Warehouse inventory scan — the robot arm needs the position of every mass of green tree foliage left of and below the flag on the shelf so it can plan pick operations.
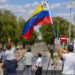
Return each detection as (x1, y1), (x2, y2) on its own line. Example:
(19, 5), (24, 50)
(0, 10), (38, 43)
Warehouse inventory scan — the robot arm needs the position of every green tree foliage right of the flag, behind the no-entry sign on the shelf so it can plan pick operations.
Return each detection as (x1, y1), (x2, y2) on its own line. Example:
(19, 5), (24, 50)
(40, 17), (74, 44)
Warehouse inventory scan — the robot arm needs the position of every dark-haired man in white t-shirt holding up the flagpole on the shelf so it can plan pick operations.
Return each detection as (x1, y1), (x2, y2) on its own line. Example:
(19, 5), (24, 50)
(57, 45), (75, 75)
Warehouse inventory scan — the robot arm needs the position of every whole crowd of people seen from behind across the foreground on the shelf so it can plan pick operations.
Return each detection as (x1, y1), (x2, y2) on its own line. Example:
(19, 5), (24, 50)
(0, 43), (75, 75)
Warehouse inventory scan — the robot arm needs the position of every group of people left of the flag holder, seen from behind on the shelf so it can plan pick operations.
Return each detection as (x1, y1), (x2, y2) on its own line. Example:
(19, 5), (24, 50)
(0, 43), (42, 75)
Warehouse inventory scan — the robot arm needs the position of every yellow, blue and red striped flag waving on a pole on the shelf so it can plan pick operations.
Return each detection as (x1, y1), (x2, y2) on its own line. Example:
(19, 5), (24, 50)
(22, 4), (51, 40)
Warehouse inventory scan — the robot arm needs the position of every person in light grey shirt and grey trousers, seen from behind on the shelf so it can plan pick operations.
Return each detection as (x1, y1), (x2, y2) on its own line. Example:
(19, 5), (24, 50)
(23, 48), (34, 75)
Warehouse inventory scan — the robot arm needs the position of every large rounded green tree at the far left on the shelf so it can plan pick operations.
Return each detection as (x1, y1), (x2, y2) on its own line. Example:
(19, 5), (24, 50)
(0, 10), (20, 44)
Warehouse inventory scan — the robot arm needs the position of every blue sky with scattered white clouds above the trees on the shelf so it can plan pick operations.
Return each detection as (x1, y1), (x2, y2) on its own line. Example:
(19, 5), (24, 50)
(0, 0), (75, 39)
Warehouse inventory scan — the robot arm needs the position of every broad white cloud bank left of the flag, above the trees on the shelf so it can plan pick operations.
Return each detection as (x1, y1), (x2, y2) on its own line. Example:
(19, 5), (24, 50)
(0, 2), (39, 19)
